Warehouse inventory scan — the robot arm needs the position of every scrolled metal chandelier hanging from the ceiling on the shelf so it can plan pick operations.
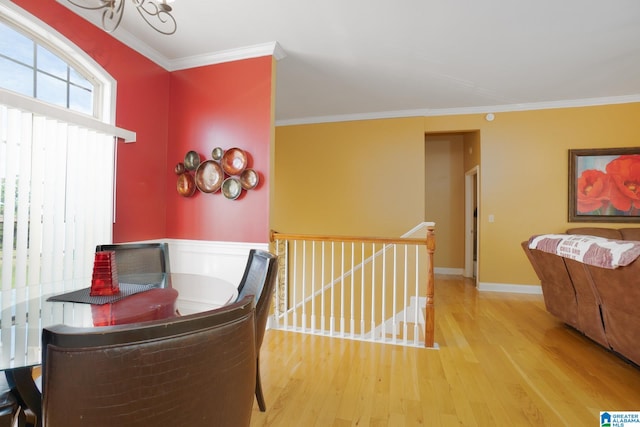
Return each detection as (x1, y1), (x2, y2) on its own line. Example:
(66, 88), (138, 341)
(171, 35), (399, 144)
(68, 0), (177, 35)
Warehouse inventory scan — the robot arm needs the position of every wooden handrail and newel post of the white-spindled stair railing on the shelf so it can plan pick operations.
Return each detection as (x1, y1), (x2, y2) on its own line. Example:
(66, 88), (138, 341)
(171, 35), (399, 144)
(269, 223), (436, 347)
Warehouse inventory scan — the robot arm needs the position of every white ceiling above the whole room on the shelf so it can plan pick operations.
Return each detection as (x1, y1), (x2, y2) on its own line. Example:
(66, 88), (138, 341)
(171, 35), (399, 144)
(58, 0), (640, 124)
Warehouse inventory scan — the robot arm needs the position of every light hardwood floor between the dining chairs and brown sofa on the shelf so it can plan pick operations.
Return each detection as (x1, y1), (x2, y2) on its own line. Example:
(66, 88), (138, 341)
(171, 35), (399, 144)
(251, 276), (640, 427)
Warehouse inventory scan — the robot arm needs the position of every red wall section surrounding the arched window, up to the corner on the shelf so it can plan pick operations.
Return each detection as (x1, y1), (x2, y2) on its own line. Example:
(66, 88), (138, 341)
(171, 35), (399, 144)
(14, 0), (170, 242)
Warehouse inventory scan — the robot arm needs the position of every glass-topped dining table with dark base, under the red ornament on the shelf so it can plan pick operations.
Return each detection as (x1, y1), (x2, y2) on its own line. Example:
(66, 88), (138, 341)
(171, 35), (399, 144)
(0, 273), (238, 425)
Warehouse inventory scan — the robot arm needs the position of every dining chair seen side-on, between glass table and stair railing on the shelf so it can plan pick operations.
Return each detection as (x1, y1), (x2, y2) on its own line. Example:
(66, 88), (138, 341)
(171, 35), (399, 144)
(238, 249), (278, 412)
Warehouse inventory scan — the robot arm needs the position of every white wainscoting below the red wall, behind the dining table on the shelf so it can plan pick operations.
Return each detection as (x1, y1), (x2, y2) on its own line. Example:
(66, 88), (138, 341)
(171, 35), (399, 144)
(142, 239), (269, 284)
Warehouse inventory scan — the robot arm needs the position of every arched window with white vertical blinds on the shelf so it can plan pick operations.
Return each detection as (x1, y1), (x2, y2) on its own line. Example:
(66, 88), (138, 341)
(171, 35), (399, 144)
(0, 3), (135, 308)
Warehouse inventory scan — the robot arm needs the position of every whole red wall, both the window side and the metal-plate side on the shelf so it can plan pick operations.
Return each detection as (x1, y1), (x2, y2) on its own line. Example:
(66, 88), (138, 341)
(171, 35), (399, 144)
(14, 0), (271, 242)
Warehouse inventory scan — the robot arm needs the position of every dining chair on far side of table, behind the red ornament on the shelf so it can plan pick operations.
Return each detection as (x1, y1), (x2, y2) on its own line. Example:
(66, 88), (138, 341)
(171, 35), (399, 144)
(96, 243), (171, 283)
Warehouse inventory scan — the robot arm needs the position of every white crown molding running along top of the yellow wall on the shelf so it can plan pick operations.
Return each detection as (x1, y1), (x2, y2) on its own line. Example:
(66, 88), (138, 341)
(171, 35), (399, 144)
(276, 94), (640, 126)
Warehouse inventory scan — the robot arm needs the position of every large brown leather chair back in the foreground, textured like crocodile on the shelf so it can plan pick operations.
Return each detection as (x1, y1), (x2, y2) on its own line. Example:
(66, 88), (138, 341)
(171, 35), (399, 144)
(42, 296), (256, 427)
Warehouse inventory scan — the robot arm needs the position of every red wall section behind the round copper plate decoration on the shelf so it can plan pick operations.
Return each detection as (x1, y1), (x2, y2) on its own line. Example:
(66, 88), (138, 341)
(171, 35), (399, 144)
(167, 56), (272, 242)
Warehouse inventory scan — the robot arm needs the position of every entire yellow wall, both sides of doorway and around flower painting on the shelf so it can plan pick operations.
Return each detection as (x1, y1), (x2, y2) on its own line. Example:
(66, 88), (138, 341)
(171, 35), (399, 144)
(272, 103), (640, 284)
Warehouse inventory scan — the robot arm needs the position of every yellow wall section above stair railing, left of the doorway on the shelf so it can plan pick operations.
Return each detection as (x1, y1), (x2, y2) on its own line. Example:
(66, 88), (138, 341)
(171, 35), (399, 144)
(271, 118), (425, 237)
